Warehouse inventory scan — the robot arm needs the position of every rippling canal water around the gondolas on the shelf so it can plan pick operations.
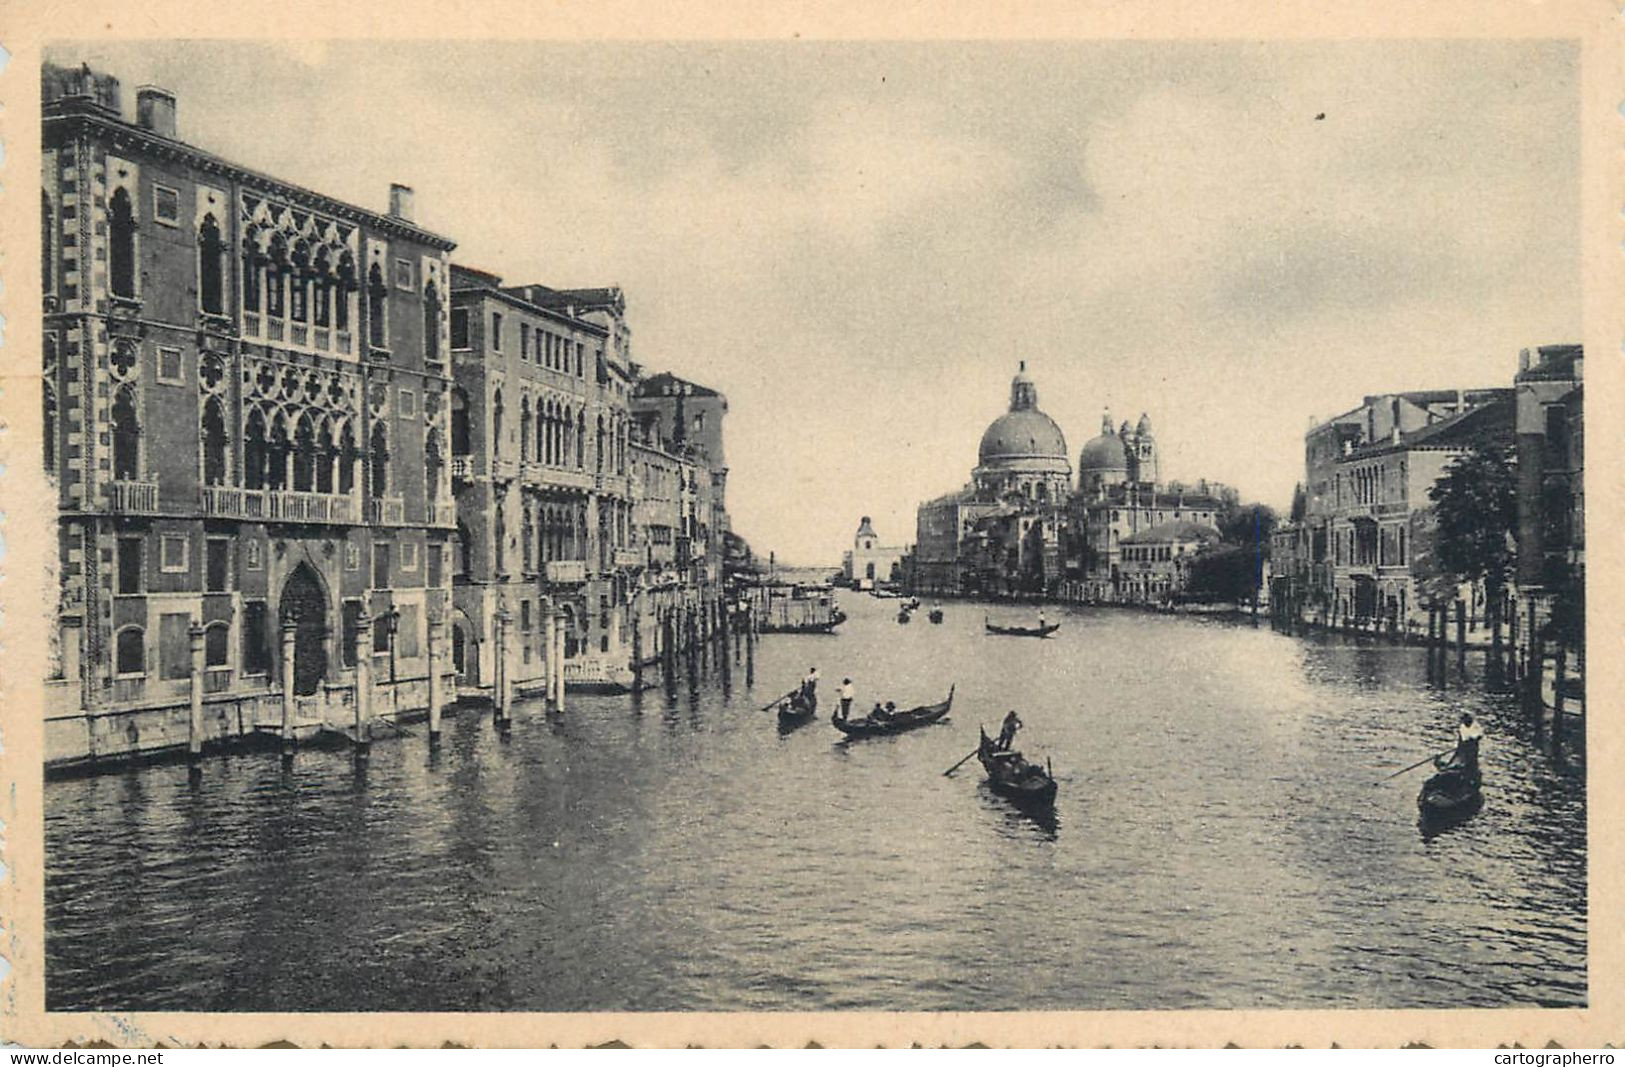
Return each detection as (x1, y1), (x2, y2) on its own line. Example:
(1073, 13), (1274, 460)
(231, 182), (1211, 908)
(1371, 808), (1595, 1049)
(46, 594), (1586, 1012)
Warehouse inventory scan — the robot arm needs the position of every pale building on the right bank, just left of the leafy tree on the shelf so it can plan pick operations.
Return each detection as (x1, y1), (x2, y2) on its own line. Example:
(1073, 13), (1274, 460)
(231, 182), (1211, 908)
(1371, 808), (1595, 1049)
(1276, 388), (1513, 632)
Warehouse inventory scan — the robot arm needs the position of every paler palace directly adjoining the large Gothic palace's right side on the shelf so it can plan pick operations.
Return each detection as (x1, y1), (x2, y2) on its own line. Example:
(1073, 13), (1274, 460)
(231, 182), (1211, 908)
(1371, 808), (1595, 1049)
(450, 266), (644, 695)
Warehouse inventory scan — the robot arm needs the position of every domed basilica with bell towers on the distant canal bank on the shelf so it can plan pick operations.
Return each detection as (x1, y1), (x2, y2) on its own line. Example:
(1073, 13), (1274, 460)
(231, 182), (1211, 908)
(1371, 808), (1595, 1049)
(913, 362), (1235, 601)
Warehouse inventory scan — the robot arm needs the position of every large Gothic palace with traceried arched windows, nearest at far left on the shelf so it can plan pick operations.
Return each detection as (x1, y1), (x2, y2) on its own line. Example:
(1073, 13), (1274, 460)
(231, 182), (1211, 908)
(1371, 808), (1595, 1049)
(41, 65), (455, 763)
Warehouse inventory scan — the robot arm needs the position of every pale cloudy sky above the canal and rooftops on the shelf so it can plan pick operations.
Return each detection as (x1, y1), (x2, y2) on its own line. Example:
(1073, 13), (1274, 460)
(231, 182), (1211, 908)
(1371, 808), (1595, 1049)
(49, 41), (1581, 562)
